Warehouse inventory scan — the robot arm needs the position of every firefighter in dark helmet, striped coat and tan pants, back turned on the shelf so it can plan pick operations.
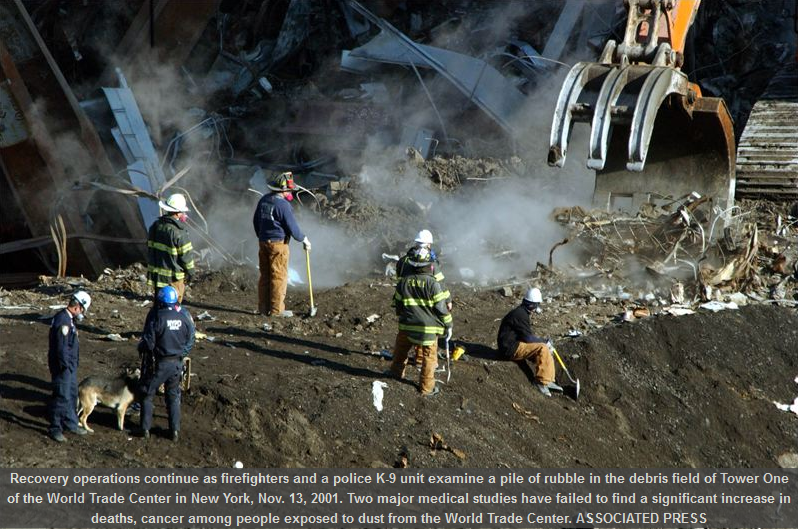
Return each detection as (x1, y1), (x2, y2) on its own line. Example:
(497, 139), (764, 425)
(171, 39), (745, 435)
(390, 248), (452, 396)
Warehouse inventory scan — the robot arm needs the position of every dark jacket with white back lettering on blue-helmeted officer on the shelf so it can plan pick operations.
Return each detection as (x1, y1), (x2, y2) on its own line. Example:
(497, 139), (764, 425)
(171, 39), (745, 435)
(140, 304), (194, 361)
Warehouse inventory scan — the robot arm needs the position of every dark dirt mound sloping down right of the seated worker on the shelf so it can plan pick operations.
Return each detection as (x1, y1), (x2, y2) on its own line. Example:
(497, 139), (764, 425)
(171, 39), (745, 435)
(569, 306), (798, 467)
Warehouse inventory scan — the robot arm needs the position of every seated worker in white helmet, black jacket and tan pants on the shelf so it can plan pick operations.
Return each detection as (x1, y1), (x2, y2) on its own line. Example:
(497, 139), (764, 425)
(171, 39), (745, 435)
(496, 288), (562, 397)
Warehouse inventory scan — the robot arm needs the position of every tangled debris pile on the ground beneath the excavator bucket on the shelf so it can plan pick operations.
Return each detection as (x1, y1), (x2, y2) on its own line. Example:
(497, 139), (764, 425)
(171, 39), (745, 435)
(539, 194), (798, 319)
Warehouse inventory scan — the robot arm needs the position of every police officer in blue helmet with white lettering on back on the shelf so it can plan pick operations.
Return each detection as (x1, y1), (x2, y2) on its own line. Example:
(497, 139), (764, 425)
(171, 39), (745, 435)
(139, 286), (194, 441)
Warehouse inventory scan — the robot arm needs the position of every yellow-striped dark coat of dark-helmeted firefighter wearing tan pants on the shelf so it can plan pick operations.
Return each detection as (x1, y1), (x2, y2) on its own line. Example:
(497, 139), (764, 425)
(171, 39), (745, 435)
(393, 273), (452, 345)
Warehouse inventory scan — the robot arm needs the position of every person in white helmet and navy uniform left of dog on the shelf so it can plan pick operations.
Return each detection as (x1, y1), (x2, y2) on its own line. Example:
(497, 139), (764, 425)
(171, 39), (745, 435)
(47, 290), (91, 443)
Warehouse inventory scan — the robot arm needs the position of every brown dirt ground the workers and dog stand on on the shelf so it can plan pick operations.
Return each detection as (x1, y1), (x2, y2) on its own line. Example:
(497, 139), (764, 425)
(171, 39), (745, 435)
(0, 262), (798, 467)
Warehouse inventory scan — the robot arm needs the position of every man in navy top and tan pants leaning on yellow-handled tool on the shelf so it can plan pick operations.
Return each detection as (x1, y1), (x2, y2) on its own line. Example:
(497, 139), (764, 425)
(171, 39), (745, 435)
(252, 172), (310, 318)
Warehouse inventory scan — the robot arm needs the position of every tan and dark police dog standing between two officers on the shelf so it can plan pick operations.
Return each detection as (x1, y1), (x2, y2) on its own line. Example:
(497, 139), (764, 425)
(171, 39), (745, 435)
(78, 368), (141, 432)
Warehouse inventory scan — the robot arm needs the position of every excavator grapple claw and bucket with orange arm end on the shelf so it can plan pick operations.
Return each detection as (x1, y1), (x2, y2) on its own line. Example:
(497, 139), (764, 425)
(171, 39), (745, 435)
(548, 0), (735, 221)
